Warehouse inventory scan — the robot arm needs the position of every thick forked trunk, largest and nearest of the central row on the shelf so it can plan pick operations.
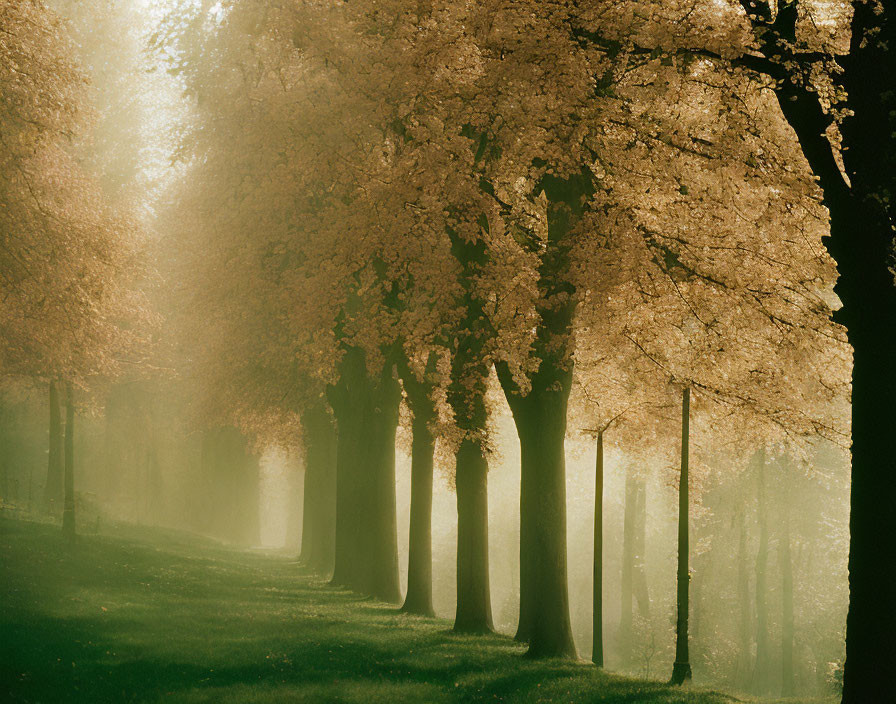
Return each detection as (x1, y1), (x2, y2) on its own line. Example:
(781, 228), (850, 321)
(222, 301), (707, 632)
(495, 168), (594, 658)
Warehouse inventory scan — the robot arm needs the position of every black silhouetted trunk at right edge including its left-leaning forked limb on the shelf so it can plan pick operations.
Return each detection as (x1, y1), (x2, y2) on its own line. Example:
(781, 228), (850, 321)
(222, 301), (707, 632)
(720, 5), (896, 704)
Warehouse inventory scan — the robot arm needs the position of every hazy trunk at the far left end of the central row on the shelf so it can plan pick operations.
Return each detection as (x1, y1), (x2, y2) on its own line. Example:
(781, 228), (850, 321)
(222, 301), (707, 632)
(299, 400), (337, 574)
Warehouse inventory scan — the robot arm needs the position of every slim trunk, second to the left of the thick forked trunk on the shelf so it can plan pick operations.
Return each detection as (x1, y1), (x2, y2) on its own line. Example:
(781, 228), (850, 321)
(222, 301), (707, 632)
(401, 410), (435, 616)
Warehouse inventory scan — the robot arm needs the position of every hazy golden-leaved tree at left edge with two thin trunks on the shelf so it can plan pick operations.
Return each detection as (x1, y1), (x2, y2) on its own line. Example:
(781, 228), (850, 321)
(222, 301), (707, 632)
(0, 2), (149, 536)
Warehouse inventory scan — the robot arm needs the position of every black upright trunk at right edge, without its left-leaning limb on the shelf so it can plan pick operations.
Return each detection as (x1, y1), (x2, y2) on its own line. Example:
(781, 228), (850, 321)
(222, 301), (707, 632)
(836, 12), (896, 704)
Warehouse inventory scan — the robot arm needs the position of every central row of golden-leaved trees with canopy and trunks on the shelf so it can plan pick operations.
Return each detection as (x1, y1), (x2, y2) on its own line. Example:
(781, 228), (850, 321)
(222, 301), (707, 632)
(150, 3), (848, 679)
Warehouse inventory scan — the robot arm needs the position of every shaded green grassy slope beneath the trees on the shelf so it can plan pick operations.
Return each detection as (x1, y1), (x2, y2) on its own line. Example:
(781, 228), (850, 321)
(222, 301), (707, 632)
(0, 517), (840, 704)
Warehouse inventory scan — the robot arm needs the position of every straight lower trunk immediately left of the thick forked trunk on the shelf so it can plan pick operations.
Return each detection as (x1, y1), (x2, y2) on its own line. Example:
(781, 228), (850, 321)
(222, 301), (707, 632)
(454, 438), (494, 633)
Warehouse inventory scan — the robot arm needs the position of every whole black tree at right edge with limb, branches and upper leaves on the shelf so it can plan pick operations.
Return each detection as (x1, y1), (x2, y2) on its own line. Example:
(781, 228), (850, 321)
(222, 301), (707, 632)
(576, 0), (896, 702)
